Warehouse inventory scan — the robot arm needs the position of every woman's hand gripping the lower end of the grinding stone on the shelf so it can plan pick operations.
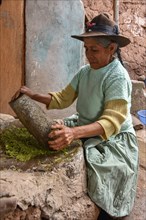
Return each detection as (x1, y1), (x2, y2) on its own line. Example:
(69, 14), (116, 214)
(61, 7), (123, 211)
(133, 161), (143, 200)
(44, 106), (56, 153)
(48, 124), (74, 150)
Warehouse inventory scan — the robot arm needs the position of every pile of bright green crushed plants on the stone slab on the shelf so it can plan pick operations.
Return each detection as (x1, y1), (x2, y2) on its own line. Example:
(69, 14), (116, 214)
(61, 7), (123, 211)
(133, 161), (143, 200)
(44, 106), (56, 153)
(1, 127), (56, 161)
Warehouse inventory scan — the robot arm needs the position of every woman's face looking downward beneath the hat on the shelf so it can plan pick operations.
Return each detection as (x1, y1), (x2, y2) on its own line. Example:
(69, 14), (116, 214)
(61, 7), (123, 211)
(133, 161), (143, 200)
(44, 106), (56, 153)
(84, 38), (114, 69)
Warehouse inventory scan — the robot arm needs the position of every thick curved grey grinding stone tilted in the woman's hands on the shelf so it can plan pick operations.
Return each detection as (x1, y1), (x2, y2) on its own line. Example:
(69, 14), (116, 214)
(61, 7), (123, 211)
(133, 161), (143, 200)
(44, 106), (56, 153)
(9, 94), (52, 149)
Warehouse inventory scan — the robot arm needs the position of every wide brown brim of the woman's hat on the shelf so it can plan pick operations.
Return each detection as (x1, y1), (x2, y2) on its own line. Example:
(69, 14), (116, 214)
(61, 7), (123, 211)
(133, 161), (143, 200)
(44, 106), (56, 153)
(71, 32), (131, 47)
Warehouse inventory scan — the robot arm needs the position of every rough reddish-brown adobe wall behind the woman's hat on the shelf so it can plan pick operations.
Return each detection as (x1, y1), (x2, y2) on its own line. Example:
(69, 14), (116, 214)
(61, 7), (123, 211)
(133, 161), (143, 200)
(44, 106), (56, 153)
(82, 0), (146, 79)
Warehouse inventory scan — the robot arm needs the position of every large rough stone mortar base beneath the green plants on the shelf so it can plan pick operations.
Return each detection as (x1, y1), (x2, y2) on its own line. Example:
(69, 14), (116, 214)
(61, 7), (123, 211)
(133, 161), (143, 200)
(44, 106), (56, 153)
(0, 114), (99, 220)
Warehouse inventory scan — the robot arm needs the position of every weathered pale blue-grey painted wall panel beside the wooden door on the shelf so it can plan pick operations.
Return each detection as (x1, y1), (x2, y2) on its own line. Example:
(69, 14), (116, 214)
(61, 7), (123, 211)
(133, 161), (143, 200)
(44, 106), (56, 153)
(25, 0), (84, 118)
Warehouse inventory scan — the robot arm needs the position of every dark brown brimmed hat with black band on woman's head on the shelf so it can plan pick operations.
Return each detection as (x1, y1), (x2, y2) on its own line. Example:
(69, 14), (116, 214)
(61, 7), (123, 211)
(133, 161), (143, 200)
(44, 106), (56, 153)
(71, 14), (130, 47)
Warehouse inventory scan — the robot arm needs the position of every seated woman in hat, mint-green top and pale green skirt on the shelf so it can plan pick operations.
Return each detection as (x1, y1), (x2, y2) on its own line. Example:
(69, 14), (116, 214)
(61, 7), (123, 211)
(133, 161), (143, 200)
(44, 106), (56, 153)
(21, 14), (138, 217)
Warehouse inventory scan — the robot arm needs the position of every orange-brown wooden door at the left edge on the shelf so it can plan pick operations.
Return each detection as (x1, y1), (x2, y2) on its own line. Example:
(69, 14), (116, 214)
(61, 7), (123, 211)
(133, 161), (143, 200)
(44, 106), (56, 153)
(0, 0), (24, 115)
